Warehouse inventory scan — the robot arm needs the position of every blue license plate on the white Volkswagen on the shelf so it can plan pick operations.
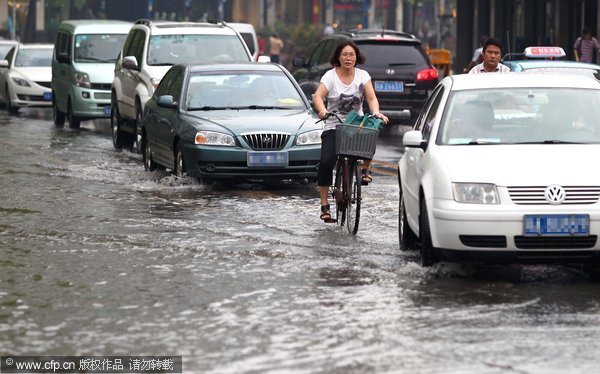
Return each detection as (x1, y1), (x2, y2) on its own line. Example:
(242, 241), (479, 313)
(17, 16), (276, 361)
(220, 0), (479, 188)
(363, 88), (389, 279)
(523, 214), (590, 236)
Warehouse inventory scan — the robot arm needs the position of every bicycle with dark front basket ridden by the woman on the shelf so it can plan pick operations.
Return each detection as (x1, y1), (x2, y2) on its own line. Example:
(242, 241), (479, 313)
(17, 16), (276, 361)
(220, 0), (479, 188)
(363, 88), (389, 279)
(317, 112), (381, 235)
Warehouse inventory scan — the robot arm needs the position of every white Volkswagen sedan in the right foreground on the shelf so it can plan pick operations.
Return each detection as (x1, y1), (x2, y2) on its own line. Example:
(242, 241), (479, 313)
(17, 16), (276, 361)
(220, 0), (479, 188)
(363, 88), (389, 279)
(398, 73), (600, 266)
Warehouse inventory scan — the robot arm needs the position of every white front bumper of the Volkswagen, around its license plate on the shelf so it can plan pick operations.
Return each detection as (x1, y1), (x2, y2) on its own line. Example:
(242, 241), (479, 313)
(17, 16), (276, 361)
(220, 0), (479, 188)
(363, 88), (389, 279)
(428, 199), (600, 255)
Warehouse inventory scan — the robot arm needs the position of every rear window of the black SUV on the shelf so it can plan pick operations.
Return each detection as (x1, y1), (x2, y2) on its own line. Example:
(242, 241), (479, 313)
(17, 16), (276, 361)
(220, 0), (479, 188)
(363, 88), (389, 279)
(358, 43), (427, 68)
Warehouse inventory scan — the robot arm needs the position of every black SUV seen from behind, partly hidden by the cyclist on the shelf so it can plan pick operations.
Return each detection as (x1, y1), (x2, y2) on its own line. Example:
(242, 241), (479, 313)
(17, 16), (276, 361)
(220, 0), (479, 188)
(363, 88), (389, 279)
(293, 29), (438, 124)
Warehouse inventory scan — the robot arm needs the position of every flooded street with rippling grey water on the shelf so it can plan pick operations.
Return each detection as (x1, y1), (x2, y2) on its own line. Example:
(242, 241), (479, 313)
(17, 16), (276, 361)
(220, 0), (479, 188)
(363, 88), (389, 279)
(0, 110), (600, 373)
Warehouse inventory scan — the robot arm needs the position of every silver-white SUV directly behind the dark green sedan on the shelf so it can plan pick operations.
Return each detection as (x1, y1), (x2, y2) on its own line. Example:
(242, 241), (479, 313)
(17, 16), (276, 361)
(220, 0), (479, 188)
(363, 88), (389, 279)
(110, 19), (252, 152)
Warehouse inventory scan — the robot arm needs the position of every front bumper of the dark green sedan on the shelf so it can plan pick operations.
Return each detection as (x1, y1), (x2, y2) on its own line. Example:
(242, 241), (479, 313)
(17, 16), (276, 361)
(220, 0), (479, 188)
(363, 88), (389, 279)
(182, 144), (321, 179)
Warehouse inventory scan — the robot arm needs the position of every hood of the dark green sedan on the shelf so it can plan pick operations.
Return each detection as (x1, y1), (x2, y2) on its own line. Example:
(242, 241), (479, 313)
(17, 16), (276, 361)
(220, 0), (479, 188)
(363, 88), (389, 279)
(187, 109), (322, 135)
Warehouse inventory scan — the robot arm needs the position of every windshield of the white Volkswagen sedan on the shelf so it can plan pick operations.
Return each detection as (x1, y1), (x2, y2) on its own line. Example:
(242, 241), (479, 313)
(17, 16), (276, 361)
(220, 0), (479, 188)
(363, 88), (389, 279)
(437, 88), (600, 145)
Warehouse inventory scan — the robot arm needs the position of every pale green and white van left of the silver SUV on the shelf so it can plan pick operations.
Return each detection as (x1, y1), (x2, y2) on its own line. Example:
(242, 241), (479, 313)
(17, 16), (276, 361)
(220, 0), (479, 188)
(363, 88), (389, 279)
(51, 20), (132, 128)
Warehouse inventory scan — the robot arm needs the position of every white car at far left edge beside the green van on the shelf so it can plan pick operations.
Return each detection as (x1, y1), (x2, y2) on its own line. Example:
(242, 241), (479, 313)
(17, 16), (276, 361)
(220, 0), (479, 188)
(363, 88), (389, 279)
(0, 44), (53, 114)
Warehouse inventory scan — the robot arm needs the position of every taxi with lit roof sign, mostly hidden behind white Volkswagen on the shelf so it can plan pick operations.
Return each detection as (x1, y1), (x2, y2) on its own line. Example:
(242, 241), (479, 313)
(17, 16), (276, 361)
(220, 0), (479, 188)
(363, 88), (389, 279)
(502, 46), (600, 78)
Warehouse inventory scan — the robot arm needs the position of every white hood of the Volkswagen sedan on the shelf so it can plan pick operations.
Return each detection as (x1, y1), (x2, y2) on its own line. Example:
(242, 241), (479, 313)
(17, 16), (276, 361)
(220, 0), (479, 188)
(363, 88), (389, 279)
(440, 144), (600, 186)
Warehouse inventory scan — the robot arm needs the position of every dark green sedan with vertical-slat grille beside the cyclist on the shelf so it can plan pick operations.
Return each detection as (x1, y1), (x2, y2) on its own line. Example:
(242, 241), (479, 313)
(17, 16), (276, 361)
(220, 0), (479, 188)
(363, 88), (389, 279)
(142, 62), (322, 180)
